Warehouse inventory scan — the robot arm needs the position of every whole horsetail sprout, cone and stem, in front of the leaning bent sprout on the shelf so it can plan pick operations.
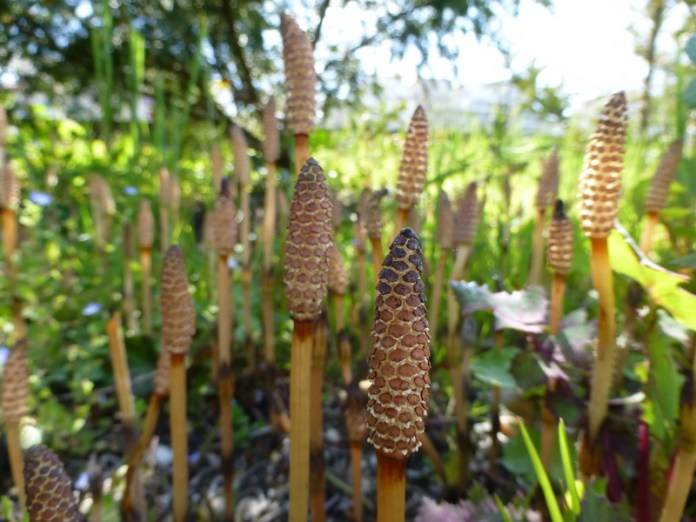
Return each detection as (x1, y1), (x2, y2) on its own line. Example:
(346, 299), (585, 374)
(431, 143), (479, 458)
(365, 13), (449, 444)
(160, 245), (196, 522)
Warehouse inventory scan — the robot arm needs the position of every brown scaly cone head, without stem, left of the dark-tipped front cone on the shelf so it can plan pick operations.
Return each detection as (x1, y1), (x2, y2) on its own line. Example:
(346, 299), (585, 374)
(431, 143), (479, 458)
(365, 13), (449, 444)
(283, 158), (333, 321)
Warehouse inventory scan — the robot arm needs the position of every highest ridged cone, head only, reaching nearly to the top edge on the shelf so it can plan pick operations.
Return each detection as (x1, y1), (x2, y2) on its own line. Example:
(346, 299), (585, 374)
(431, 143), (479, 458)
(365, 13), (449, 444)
(280, 14), (317, 134)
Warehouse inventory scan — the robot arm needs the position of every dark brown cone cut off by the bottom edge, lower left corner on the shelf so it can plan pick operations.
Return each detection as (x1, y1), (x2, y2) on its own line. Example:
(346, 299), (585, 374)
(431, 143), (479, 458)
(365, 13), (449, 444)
(24, 445), (82, 522)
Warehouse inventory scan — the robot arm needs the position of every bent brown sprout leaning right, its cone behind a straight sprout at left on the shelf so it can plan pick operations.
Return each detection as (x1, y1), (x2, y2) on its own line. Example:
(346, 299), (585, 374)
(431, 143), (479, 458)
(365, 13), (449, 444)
(121, 350), (171, 517)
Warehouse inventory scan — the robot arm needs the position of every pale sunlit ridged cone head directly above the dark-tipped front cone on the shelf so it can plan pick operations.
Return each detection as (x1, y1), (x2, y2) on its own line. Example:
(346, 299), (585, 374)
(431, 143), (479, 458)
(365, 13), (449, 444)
(396, 105), (428, 209)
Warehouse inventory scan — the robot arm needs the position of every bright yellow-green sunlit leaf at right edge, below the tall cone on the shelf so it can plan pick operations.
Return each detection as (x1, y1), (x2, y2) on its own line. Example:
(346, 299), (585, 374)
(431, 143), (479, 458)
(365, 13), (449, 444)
(609, 224), (696, 330)
